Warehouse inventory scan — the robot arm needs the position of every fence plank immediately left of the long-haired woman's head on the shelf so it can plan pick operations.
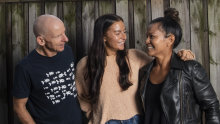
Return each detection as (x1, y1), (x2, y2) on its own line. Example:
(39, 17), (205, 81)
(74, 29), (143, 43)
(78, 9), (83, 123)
(82, 1), (95, 55)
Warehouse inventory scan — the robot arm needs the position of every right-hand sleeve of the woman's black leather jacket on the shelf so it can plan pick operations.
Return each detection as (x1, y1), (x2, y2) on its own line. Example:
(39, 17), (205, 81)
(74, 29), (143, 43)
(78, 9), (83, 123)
(192, 63), (220, 124)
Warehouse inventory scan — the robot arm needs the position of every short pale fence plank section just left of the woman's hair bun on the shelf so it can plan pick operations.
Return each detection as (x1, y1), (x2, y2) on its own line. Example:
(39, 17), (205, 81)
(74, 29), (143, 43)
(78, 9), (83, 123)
(151, 0), (164, 19)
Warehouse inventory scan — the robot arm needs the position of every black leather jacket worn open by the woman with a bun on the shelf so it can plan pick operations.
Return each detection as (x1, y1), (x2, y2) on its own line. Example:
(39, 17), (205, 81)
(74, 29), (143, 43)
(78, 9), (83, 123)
(139, 52), (220, 124)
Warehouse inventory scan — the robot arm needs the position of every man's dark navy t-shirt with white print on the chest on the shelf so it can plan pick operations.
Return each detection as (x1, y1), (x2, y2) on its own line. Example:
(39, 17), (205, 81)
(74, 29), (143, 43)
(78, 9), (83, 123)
(12, 45), (82, 124)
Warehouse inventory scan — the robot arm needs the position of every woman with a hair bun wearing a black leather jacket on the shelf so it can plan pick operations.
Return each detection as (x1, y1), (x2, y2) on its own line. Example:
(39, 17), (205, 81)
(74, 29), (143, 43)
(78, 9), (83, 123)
(139, 8), (220, 124)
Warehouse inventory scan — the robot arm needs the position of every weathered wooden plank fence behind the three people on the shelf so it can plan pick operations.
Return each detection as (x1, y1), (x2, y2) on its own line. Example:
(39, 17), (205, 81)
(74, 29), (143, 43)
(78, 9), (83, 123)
(0, 0), (220, 124)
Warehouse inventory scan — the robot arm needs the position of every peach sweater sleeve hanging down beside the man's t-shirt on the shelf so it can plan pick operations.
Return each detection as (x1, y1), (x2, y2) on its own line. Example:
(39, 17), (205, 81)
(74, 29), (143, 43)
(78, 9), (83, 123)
(75, 57), (91, 118)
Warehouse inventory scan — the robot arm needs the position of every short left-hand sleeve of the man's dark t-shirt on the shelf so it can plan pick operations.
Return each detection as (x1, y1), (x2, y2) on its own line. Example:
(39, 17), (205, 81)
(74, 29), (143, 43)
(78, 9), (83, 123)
(12, 64), (30, 98)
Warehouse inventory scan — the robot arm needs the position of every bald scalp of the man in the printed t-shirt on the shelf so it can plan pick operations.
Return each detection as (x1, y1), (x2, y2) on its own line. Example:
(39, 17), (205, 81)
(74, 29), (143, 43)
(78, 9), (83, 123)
(33, 15), (63, 37)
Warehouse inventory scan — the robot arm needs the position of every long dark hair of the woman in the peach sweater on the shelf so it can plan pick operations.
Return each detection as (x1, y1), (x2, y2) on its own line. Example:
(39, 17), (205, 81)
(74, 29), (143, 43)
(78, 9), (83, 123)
(85, 14), (132, 109)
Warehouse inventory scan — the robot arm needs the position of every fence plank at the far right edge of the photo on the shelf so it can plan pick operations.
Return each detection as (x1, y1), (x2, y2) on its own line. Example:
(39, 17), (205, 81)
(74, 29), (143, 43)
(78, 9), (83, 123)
(208, 0), (220, 100)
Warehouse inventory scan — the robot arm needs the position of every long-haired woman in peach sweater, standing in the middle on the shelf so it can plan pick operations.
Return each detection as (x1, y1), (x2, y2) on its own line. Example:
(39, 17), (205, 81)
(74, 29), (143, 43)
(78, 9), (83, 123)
(76, 14), (192, 124)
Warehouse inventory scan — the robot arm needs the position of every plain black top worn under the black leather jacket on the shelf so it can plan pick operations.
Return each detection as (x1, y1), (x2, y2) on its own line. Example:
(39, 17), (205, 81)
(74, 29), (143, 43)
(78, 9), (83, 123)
(144, 80), (167, 124)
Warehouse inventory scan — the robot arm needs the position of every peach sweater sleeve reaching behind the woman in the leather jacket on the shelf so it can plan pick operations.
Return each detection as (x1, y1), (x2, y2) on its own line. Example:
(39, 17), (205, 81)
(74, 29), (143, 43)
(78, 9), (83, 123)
(128, 49), (153, 68)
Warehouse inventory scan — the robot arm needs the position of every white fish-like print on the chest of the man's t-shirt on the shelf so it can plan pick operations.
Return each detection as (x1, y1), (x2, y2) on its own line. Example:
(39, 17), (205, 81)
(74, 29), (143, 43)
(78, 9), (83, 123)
(41, 62), (77, 104)
